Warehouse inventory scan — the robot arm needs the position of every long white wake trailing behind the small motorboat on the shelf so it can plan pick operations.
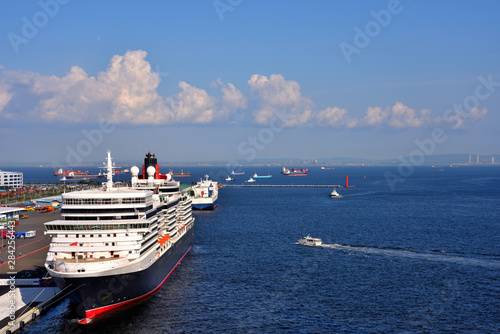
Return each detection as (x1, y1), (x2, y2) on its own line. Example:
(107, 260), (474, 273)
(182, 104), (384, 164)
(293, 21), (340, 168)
(321, 244), (500, 269)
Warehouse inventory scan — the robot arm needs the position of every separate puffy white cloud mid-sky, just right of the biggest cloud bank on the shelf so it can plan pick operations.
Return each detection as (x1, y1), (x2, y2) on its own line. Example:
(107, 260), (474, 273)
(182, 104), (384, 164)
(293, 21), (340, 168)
(248, 74), (314, 127)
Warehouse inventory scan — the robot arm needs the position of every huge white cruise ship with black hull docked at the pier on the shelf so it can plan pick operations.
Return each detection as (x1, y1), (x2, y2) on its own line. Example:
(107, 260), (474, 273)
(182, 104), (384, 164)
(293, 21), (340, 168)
(45, 151), (194, 323)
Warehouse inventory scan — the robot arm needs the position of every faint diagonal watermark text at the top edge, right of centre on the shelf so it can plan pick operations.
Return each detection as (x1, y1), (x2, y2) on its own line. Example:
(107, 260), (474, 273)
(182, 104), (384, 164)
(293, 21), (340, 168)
(339, 0), (411, 64)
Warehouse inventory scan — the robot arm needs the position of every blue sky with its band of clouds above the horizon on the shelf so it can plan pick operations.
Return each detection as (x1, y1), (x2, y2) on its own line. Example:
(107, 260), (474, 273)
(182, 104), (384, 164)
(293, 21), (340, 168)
(0, 0), (500, 165)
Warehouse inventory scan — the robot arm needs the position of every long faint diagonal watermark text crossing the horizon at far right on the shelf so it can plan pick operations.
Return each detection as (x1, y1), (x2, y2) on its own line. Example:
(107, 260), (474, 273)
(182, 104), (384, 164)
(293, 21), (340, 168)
(384, 74), (500, 191)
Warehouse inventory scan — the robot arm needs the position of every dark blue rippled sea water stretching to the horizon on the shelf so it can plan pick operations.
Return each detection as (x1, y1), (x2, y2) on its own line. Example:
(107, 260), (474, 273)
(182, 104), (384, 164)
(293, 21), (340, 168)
(14, 166), (500, 334)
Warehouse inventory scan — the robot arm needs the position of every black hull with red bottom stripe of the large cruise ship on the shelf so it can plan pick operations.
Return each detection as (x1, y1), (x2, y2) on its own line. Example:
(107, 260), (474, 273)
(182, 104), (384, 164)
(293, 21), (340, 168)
(53, 226), (194, 323)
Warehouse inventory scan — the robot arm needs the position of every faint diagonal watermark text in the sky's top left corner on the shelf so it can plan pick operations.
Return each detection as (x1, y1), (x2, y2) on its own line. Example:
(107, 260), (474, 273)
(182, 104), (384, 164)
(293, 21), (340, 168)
(7, 0), (69, 53)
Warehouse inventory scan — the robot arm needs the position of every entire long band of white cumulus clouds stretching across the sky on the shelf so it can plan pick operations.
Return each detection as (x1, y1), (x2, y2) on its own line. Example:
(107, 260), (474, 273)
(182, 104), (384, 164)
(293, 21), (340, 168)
(0, 50), (487, 130)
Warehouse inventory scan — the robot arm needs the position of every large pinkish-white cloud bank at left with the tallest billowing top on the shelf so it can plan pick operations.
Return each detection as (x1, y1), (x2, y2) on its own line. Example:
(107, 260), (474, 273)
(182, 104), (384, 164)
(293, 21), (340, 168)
(0, 50), (246, 124)
